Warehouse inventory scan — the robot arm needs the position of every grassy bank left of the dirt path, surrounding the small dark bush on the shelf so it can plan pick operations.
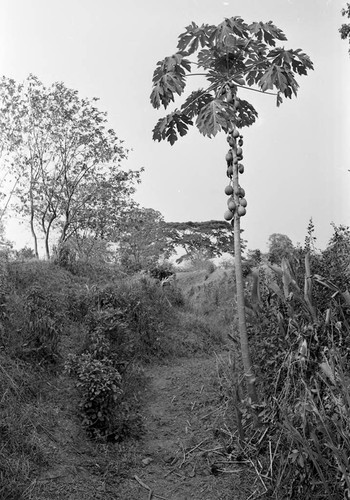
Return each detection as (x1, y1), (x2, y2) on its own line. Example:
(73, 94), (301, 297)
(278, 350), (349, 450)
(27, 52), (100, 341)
(0, 261), (228, 500)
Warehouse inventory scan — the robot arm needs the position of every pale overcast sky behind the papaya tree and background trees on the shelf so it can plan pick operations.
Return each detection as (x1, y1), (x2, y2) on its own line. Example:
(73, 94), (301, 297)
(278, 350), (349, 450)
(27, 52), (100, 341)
(0, 0), (350, 251)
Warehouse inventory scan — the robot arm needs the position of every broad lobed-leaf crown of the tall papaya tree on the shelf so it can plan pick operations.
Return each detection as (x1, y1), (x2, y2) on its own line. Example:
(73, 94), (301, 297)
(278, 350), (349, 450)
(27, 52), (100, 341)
(150, 16), (313, 145)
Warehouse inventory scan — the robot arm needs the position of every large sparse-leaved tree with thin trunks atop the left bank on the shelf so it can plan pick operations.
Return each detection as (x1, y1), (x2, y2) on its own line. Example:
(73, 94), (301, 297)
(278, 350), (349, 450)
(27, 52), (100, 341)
(0, 75), (138, 257)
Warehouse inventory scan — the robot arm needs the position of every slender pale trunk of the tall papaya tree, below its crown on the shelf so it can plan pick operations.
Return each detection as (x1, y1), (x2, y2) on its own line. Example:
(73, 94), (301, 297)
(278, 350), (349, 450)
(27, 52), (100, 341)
(232, 143), (258, 403)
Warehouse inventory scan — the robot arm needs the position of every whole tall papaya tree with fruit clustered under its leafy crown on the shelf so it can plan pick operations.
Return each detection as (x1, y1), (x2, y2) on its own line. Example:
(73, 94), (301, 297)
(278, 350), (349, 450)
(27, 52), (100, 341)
(150, 16), (313, 402)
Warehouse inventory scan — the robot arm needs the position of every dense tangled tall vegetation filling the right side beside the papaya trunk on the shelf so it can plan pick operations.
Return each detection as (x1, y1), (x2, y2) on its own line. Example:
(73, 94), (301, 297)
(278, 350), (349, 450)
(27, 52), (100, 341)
(224, 226), (350, 499)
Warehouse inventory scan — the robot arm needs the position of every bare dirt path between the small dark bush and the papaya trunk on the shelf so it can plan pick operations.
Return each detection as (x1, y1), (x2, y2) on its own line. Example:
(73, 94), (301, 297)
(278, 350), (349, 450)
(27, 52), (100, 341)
(116, 356), (249, 500)
